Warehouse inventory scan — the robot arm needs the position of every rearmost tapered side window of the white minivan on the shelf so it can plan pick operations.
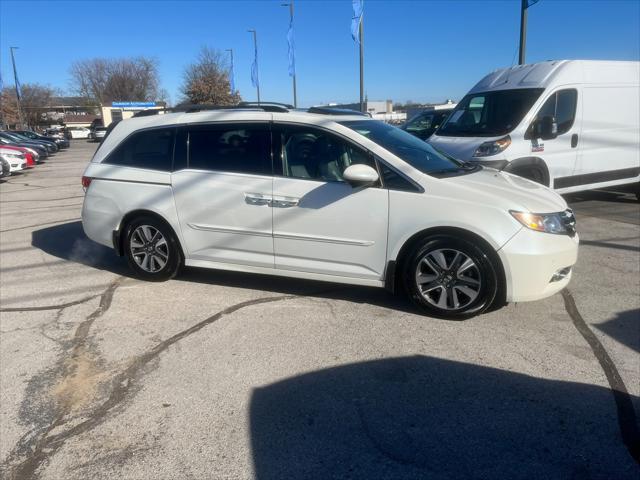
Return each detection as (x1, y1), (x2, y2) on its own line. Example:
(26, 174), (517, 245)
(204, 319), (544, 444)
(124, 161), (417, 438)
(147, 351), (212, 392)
(103, 128), (175, 172)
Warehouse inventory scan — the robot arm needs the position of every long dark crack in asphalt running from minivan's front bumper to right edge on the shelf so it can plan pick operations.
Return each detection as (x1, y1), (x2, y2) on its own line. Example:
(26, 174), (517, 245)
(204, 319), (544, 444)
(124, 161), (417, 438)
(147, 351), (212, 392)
(561, 288), (640, 464)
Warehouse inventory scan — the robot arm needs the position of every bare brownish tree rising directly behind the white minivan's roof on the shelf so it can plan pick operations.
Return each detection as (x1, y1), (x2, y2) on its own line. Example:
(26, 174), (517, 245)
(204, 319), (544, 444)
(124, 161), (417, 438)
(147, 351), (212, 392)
(180, 47), (241, 105)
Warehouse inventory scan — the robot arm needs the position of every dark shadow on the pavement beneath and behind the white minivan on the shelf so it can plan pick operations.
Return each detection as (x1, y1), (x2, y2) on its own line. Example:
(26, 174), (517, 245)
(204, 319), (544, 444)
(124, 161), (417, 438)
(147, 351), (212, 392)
(31, 222), (420, 321)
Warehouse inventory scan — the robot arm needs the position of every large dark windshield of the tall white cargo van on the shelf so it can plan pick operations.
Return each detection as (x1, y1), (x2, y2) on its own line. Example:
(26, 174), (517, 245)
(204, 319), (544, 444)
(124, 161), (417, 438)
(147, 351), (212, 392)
(436, 88), (544, 137)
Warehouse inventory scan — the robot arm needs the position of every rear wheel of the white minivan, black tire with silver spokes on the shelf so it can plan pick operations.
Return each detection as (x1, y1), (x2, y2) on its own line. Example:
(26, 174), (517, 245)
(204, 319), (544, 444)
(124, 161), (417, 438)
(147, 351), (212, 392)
(123, 217), (183, 282)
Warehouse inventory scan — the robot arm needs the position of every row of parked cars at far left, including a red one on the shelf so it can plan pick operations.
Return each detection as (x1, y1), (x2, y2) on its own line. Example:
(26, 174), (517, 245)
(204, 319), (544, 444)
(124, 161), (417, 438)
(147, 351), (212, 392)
(0, 130), (69, 177)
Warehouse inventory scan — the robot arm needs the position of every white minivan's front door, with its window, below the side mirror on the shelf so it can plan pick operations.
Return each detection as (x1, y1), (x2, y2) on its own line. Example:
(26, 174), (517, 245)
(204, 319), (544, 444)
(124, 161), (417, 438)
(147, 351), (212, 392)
(272, 125), (389, 280)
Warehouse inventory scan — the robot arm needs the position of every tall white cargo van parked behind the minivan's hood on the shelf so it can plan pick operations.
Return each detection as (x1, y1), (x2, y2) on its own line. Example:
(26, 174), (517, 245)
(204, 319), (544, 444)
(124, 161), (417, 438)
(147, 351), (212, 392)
(429, 60), (640, 193)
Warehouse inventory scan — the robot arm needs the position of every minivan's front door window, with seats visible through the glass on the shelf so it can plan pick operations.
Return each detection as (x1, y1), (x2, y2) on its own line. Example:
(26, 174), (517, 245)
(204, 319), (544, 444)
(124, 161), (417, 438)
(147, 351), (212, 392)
(279, 126), (376, 182)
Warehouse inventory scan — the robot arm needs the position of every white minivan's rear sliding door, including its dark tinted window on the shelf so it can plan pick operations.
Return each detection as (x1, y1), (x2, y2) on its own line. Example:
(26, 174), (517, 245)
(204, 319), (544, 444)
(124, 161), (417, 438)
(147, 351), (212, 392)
(172, 122), (273, 268)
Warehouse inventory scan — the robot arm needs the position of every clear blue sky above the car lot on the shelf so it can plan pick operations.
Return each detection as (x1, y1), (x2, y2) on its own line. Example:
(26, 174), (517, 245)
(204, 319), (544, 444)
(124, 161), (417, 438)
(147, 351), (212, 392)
(0, 0), (640, 107)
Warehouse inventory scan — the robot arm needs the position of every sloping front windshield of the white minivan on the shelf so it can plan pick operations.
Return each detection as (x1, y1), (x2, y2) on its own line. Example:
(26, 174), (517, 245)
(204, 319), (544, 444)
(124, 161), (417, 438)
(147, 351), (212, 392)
(339, 120), (477, 176)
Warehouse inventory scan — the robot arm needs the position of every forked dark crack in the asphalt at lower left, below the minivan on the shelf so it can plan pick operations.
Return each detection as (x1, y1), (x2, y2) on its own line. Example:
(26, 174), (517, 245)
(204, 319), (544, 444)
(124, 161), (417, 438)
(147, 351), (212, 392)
(4, 290), (299, 480)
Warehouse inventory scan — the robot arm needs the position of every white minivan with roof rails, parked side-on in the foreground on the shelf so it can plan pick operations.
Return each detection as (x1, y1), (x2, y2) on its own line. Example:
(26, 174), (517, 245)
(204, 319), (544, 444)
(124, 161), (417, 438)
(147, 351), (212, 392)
(82, 104), (578, 319)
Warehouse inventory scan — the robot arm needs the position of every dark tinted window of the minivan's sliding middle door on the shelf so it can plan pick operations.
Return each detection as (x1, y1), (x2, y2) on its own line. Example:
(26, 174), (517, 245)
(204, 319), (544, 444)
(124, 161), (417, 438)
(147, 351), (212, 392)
(188, 124), (271, 175)
